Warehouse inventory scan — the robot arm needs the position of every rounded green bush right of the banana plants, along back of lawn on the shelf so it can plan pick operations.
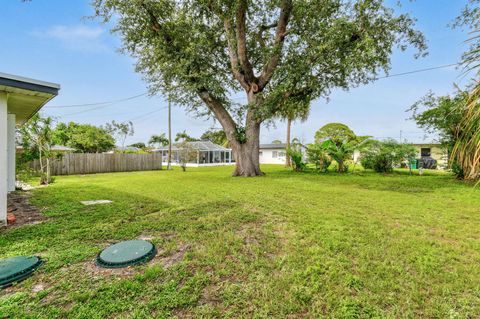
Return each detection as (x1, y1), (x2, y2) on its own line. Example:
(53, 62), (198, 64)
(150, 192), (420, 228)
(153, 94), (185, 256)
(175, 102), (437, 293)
(360, 139), (417, 173)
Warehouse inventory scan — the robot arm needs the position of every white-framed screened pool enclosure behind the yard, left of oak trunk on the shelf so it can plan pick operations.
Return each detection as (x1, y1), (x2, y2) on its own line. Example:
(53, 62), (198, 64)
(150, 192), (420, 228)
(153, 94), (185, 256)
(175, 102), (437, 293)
(153, 141), (235, 166)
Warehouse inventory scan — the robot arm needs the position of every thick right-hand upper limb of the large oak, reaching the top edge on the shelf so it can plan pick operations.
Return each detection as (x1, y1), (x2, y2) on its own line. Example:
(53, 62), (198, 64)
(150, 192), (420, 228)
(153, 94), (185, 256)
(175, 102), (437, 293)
(258, 0), (293, 90)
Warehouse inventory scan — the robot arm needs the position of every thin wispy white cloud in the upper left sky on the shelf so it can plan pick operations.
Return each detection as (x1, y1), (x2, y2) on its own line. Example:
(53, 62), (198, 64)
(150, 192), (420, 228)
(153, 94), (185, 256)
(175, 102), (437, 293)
(32, 25), (107, 52)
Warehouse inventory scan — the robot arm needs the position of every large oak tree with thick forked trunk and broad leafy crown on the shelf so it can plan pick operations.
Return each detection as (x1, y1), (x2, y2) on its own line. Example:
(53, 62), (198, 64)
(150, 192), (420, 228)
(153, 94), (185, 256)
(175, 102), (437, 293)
(93, 0), (425, 176)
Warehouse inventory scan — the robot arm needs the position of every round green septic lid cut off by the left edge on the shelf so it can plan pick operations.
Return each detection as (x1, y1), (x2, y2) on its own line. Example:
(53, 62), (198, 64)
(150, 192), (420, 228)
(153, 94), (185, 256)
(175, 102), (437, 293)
(0, 256), (42, 288)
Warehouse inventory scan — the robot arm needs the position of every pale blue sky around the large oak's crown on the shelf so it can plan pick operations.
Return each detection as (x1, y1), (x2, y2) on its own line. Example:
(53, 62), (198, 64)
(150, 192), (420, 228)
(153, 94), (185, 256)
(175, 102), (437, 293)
(0, 0), (469, 143)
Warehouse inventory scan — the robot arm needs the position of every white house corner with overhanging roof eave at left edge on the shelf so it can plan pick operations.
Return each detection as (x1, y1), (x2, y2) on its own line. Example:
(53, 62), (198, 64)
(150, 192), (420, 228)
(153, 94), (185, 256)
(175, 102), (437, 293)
(0, 73), (60, 225)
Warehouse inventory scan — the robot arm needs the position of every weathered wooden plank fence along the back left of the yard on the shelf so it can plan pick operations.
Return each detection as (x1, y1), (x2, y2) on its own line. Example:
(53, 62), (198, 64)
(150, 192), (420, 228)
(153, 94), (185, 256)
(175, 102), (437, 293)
(31, 153), (162, 175)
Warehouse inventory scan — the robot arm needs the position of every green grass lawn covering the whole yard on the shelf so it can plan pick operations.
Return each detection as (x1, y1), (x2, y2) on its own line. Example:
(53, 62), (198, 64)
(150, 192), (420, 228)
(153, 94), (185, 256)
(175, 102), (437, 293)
(0, 166), (480, 319)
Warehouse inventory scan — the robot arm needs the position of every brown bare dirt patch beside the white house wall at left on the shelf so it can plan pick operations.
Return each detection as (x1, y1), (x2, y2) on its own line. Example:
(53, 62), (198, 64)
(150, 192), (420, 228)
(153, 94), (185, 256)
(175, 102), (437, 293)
(3, 192), (47, 229)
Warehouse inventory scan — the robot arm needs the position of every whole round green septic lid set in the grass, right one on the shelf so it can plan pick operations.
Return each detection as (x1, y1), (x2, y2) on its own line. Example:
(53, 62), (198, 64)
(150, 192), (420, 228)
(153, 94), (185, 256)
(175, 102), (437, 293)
(97, 240), (157, 268)
